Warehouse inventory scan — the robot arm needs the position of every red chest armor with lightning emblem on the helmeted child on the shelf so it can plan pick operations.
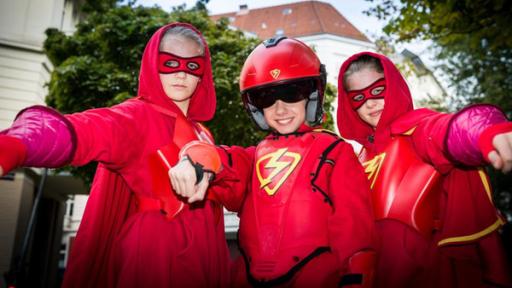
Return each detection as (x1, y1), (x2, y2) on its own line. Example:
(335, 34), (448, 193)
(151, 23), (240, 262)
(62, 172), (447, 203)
(239, 132), (337, 281)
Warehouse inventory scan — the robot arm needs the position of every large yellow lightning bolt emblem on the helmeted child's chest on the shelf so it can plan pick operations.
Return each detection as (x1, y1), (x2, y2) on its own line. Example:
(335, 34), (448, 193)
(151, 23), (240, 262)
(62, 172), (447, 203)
(256, 148), (301, 196)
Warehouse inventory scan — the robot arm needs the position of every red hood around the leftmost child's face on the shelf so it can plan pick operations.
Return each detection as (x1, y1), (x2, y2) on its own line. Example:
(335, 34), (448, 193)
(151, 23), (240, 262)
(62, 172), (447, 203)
(138, 23), (216, 121)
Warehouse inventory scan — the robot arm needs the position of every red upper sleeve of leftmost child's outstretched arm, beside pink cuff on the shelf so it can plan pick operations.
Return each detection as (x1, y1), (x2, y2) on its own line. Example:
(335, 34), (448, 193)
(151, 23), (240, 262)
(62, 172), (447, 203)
(66, 101), (145, 169)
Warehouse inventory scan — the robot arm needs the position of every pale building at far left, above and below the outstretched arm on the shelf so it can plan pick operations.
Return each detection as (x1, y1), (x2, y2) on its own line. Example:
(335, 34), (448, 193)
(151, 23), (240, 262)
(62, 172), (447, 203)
(0, 0), (80, 287)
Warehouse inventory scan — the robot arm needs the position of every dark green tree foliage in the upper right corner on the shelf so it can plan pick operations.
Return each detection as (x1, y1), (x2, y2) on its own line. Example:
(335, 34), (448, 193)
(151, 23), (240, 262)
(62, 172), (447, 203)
(367, 0), (512, 116)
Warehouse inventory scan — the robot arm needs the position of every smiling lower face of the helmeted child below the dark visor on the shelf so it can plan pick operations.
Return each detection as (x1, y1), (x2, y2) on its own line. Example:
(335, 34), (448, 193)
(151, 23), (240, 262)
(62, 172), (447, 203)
(263, 99), (306, 134)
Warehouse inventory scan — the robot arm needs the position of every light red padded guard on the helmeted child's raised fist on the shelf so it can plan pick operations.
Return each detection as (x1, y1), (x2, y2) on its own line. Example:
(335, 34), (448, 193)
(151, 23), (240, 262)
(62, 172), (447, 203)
(179, 141), (222, 184)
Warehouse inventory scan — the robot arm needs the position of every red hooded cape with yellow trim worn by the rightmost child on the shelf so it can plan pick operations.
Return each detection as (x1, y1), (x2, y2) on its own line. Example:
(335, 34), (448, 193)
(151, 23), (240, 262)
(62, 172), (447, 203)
(337, 52), (507, 287)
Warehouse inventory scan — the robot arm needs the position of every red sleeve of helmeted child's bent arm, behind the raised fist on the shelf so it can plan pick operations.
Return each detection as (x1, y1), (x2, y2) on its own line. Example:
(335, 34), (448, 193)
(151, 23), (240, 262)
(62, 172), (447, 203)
(208, 146), (255, 212)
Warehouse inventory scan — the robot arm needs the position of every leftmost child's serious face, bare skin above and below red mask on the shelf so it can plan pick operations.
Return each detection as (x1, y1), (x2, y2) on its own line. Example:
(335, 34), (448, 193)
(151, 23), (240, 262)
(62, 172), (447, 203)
(160, 36), (201, 107)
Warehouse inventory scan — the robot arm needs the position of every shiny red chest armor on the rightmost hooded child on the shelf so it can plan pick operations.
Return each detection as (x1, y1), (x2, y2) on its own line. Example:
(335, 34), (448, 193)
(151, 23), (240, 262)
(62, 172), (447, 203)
(360, 136), (441, 237)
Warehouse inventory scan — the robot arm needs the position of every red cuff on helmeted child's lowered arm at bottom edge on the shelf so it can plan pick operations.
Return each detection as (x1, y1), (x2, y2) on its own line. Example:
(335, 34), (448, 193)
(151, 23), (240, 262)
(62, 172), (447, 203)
(338, 250), (377, 288)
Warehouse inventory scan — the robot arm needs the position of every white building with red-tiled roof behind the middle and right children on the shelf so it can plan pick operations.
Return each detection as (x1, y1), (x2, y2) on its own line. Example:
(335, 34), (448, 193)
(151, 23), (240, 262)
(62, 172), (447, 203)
(211, 1), (446, 126)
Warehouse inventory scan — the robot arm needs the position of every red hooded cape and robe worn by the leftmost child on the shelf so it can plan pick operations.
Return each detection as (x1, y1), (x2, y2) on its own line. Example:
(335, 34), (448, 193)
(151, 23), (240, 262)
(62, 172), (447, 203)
(63, 23), (229, 287)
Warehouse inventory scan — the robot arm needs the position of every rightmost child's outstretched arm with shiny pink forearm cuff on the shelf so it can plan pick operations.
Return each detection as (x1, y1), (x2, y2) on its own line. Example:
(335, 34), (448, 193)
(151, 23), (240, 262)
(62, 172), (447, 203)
(404, 104), (512, 173)
